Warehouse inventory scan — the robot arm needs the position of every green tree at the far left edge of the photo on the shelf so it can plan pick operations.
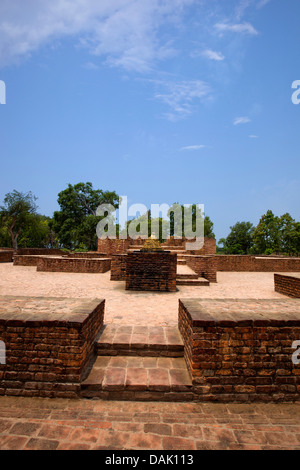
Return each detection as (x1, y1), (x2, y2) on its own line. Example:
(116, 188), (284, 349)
(0, 190), (37, 251)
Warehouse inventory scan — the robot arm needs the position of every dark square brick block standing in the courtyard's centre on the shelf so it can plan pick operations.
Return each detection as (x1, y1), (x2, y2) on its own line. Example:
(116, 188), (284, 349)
(126, 251), (177, 292)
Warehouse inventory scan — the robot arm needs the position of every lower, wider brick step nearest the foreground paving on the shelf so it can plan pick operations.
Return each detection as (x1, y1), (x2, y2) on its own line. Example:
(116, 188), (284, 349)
(81, 356), (194, 401)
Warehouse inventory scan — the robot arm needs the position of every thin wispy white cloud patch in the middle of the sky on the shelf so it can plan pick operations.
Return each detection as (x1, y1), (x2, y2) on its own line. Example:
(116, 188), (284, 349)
(149, 80), (211, 121)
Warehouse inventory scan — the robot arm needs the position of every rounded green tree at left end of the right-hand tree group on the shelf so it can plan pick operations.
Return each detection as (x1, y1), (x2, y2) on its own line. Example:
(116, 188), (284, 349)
(219, 222), (255, 255)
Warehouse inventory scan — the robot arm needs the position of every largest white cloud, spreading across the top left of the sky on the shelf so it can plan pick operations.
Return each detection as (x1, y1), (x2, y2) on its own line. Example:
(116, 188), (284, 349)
(0, 0), (196, 72)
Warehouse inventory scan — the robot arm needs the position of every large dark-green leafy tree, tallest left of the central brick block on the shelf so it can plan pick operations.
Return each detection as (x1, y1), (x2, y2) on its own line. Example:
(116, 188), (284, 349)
(51, 182), (119, 250)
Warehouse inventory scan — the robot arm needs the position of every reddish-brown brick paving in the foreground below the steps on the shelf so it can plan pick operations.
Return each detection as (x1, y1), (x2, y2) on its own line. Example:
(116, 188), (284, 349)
(0, 398), (300, 450)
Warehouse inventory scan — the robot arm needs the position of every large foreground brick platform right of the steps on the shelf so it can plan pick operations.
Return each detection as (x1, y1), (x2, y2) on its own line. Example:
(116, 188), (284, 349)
(179, 299), (300, 402)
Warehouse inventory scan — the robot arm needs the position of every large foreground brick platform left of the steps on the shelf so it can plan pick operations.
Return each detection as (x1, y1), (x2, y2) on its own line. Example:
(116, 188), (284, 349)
(0, 296), (105, 398)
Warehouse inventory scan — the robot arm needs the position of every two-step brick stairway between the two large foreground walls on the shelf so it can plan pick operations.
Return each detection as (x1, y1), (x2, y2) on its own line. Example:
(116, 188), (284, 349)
(81, 325), (193, 401)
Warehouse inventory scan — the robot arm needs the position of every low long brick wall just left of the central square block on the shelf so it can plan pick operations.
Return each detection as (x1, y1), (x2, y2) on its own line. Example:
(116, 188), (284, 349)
(37, 257), (110, 274)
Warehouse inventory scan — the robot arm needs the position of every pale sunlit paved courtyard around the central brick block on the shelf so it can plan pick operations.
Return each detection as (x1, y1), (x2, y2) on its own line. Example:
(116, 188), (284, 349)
(0, 263), (286, 326)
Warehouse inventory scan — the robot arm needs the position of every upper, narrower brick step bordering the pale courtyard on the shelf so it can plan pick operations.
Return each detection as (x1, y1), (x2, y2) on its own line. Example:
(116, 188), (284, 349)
(96, 325), (184, 357)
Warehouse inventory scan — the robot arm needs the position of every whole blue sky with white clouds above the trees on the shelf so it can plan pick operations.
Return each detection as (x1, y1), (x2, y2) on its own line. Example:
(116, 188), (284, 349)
(0, 0), (300, 239)
